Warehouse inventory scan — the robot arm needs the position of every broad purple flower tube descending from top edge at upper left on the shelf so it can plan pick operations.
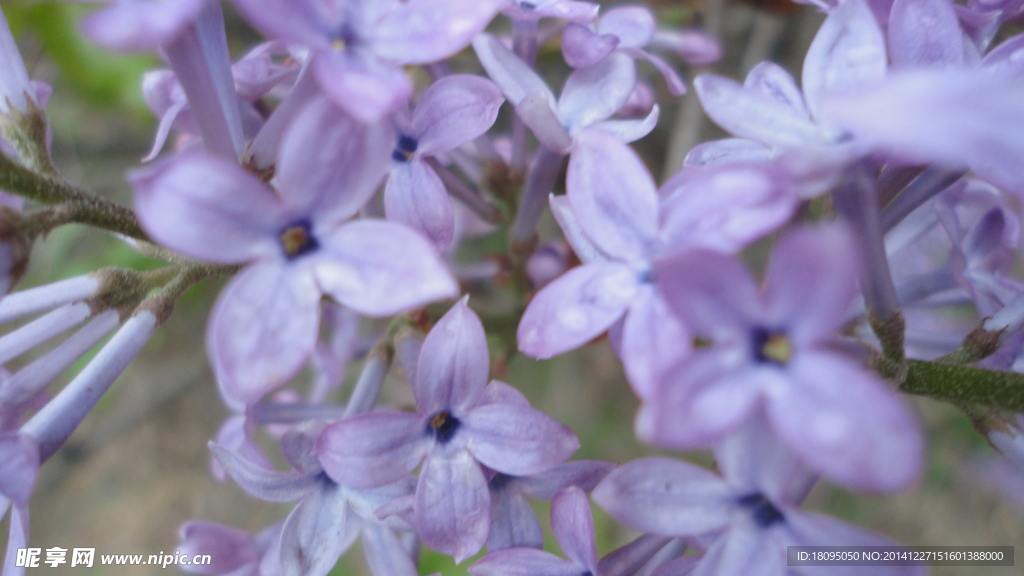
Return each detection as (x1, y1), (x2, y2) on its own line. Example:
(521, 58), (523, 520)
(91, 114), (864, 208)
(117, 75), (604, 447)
(165, 2), (245, 161)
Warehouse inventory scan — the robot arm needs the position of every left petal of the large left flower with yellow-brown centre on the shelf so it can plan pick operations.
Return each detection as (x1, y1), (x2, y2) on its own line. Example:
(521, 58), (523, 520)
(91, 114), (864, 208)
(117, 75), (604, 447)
(134, 153), (285, 263)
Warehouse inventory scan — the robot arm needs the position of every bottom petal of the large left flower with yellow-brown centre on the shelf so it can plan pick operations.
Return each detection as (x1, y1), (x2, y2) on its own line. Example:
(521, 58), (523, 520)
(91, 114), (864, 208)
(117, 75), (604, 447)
(206, 258), (319, 405)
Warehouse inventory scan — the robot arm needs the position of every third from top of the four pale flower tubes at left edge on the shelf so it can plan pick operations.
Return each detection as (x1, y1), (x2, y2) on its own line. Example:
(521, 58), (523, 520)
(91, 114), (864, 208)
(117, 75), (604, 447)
(0, 310), (121, 405)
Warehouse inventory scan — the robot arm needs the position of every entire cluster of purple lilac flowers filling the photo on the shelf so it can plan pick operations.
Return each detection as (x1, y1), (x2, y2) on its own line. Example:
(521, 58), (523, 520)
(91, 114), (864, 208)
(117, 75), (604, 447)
(0, 0), (1024, 576)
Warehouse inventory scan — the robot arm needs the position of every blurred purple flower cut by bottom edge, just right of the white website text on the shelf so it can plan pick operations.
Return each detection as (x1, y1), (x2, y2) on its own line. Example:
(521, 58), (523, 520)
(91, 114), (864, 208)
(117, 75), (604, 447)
(177, 520), (282, 576)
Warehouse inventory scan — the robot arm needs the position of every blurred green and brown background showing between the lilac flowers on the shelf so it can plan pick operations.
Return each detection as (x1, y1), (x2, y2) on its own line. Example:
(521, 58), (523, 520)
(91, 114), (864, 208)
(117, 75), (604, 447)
(0, 0), (1024, 576)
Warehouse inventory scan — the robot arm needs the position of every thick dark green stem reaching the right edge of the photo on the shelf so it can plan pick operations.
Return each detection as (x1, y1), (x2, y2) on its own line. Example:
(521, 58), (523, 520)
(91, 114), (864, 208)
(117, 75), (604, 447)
(900, 360), (1024, 412)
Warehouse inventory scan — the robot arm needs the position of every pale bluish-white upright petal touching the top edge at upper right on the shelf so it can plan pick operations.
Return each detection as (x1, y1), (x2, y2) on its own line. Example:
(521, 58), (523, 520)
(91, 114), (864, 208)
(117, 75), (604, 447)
(803, 0), (886, 118)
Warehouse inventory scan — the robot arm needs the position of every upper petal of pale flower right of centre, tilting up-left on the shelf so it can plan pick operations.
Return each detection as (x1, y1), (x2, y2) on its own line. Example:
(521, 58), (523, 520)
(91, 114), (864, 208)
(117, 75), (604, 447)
(565, 130), (657, 260)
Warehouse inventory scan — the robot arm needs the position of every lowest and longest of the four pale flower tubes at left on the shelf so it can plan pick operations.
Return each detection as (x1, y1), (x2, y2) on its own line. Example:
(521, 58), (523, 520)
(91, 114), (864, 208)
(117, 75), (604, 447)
(22, 310), (158, 461)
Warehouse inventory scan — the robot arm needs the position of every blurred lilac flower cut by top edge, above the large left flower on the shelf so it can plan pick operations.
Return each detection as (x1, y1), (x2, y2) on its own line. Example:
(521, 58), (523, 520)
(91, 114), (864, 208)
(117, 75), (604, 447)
(234, 0), (502, 122)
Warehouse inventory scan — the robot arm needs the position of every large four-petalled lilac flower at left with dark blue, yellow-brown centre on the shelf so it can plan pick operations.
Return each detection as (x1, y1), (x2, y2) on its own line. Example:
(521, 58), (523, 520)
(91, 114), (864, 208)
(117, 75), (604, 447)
(132, 99), (457, 404)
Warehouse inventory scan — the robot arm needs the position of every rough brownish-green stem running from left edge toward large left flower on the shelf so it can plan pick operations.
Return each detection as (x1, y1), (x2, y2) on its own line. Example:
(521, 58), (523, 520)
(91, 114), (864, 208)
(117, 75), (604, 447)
(0, 154), (148, 241)
